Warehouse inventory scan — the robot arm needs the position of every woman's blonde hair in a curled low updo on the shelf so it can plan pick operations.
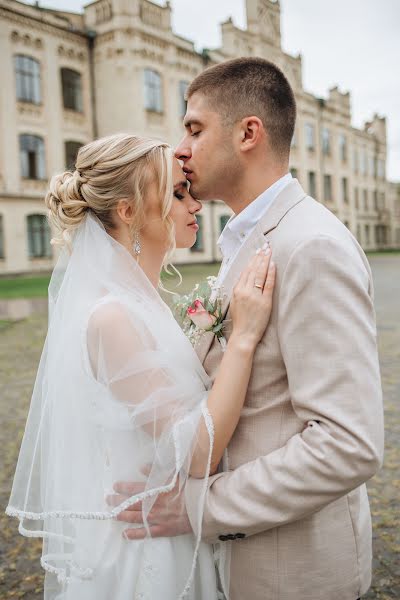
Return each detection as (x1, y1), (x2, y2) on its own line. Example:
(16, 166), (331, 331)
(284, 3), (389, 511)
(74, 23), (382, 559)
(45, 133), (175, 264)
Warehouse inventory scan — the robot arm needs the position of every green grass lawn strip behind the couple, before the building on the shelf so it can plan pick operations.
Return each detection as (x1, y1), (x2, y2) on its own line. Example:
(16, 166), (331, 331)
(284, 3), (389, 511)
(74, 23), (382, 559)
(0, 264), (219, 300)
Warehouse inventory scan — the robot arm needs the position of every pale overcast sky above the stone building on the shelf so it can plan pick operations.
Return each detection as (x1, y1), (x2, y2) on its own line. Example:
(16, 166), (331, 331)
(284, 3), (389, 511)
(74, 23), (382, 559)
(23, 0), (400, 181)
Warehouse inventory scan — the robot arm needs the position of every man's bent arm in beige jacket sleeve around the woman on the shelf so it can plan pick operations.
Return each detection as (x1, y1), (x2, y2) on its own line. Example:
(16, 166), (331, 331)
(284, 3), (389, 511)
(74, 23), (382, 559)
(186, 235), (383, 541)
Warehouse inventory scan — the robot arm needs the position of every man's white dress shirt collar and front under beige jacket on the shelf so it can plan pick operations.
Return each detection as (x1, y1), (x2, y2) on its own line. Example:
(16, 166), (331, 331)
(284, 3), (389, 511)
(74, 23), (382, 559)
(218, 173), (292, 285)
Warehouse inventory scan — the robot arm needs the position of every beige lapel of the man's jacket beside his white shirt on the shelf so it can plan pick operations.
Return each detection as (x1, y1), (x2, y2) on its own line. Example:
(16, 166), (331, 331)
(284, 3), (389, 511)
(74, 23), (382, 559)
(196, 179), (307, 363)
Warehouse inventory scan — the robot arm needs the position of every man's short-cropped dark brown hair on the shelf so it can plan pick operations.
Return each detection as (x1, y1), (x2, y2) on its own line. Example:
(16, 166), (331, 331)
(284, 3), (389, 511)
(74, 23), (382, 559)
(186, 57), (296, 156)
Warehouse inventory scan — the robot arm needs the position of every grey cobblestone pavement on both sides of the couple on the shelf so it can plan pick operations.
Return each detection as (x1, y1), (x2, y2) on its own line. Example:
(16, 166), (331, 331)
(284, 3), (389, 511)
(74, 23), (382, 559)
(0, 255), (400, 600)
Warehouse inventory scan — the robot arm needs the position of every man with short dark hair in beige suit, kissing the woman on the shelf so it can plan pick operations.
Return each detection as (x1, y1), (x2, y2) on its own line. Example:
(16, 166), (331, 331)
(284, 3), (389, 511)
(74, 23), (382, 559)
(116, 58), (383, 600)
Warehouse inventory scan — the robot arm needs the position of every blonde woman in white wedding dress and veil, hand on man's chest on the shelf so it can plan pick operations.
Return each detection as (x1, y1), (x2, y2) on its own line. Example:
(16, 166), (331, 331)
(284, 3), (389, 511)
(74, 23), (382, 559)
(7, 134), (275, 600)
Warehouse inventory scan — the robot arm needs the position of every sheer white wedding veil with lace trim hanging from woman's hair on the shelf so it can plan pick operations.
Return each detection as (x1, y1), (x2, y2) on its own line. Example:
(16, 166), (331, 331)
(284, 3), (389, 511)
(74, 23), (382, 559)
(6, 213), (213, 599)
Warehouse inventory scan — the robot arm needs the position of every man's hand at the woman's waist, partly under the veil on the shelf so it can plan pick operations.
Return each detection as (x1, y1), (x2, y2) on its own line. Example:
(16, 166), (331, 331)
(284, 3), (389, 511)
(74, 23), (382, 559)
(107, 481), (192, 540)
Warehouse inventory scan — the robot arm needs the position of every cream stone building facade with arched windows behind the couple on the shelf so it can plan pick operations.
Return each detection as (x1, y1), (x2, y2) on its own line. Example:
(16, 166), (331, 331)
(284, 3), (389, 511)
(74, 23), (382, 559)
(0, 0), (400, 274)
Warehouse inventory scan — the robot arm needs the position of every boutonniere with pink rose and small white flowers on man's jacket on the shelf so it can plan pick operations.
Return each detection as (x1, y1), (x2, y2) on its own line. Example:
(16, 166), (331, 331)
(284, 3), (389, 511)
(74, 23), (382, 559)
(174, 277), (226, 350)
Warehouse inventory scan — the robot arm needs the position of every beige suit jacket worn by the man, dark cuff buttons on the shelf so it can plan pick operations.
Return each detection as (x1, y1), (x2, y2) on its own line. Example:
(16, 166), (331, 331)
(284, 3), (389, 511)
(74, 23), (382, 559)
(186, 180), (383, 600)
